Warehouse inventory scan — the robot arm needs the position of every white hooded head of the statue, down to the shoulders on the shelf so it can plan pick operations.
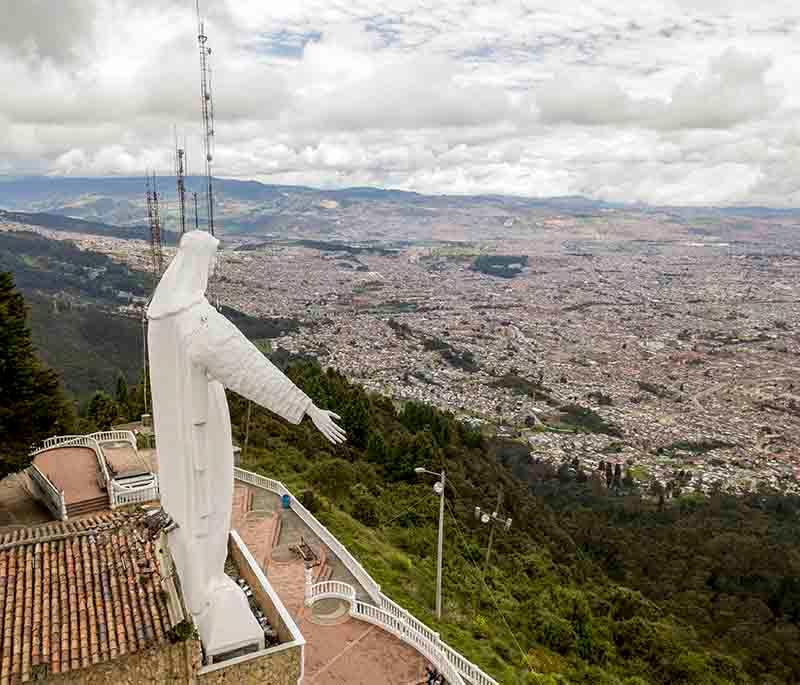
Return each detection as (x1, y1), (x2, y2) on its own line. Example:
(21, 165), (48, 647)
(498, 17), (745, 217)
(147, 231), (219, 319)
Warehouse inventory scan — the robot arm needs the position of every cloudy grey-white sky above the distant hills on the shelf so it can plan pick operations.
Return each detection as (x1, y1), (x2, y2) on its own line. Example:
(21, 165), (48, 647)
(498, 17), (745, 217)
(0, 0), (800, 206)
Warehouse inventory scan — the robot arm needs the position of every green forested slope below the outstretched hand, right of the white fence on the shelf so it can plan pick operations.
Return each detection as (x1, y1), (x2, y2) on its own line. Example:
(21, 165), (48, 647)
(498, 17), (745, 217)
(220, 363), (800, 685)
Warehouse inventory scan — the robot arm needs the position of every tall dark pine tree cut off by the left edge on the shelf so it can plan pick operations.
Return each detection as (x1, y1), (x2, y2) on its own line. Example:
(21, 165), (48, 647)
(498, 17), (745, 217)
(0, 272), (74, 477)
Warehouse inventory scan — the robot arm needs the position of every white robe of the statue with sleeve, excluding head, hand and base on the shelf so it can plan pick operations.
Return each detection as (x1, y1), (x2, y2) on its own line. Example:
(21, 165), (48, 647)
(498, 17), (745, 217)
(148, 244), (311, 616)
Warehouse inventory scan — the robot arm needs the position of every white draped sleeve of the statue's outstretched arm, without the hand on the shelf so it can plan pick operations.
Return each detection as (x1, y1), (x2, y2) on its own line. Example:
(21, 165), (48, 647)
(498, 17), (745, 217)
(187, 303), (311, 424)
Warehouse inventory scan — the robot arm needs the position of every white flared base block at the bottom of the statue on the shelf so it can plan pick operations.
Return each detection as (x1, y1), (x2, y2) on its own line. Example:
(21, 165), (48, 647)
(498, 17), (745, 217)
(195, 576), (264, 663)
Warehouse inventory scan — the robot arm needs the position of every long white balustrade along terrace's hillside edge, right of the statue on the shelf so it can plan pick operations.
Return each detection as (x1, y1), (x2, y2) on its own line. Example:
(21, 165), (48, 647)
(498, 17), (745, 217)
(234, 468), (498, 685)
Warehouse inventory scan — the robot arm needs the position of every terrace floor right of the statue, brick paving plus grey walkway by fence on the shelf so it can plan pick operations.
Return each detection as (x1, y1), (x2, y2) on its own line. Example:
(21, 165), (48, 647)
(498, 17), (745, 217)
(231, 483), (426, 685)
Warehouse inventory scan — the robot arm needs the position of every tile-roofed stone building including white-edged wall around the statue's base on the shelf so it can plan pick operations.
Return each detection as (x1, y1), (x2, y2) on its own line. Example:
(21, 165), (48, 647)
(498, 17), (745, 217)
(0, 500), (305, 685)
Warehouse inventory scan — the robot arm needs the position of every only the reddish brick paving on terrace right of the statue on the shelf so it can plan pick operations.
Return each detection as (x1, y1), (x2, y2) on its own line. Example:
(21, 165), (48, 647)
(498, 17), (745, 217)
(231, 483), (426, 685)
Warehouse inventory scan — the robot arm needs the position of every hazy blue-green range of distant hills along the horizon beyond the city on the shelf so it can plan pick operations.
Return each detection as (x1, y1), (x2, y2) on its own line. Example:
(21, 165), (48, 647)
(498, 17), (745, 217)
(0, 176), (800, 242)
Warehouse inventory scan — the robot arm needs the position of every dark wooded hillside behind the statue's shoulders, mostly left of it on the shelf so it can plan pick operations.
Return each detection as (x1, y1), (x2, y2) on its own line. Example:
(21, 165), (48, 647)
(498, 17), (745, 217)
(0, 231), (300, 401)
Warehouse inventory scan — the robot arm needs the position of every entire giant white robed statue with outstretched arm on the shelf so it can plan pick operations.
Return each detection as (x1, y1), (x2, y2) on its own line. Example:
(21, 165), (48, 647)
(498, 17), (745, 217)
(147, 231), (345, 654)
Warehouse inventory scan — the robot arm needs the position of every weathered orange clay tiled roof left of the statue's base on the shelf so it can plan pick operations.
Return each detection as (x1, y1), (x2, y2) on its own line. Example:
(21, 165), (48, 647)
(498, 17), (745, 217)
(0, 513), (171, 685)
